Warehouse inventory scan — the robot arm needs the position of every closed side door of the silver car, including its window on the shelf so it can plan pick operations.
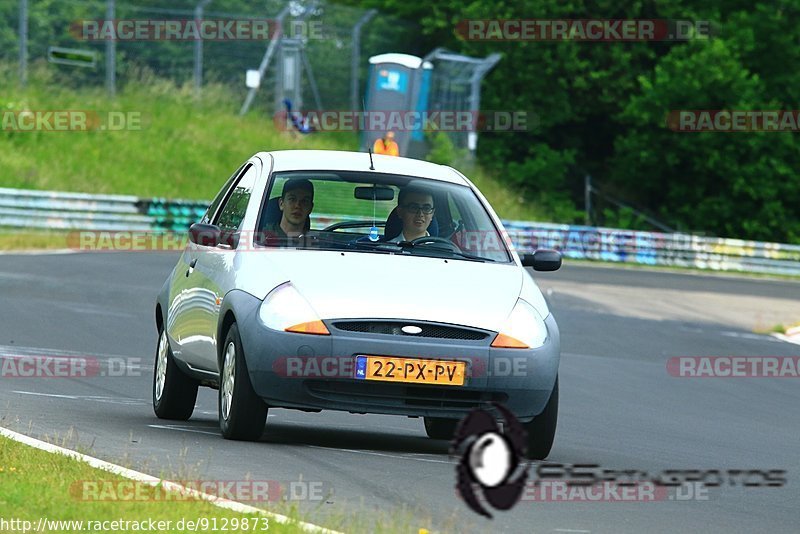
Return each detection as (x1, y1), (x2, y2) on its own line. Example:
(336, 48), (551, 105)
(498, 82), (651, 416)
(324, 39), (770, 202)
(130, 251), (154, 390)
(184, 160), (261, 372)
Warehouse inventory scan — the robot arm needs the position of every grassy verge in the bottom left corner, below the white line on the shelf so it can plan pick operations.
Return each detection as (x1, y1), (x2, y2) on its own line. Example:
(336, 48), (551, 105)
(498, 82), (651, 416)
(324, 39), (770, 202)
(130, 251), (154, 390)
(0, 437), (312, 532)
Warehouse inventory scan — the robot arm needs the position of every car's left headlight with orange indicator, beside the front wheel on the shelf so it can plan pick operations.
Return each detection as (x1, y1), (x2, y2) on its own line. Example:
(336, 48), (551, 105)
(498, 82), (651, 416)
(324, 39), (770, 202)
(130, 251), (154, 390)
(258, 282), (331, 336)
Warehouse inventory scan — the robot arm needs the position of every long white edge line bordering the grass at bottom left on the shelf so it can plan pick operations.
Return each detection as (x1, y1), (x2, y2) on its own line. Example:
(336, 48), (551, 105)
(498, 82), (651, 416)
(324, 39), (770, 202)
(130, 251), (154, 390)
(0, 427), (339, 534)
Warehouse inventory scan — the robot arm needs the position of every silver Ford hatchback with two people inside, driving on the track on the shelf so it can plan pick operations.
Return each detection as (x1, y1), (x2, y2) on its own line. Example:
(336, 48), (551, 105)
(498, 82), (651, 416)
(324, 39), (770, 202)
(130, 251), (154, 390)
(153, 150), (561, 459)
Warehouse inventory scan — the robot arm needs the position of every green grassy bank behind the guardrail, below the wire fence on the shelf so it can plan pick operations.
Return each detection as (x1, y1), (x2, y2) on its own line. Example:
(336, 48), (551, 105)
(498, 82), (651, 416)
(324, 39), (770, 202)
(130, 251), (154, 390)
(0, 64), (542, 224)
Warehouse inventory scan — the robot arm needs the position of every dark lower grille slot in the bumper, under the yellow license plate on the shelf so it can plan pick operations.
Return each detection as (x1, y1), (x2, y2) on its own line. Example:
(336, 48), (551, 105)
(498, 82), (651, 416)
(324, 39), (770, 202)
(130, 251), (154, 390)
(305, 380), (508, 410)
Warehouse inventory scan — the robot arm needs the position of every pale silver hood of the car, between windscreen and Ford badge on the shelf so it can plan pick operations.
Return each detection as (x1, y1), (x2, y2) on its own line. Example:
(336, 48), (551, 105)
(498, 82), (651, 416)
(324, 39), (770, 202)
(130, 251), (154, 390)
(247, 251), (524, 331)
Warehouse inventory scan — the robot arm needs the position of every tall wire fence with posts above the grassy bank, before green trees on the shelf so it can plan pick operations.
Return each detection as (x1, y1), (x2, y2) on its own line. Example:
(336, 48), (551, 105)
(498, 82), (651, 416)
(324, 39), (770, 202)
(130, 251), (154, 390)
(0, 0), (420, 114)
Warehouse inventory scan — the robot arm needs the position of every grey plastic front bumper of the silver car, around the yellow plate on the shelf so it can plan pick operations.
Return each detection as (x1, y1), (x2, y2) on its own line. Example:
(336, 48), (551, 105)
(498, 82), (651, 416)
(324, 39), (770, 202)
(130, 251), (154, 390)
(238, 298), (560, 422)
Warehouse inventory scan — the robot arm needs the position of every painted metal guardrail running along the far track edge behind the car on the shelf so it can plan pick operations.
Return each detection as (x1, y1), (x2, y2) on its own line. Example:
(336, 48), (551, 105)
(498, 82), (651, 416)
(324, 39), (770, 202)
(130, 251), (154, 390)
(0, 188), (800, 275)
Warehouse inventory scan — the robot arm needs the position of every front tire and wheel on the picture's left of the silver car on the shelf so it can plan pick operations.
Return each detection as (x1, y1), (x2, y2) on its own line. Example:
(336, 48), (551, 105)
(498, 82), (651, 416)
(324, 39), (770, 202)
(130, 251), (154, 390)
(218, 323), (267, 441)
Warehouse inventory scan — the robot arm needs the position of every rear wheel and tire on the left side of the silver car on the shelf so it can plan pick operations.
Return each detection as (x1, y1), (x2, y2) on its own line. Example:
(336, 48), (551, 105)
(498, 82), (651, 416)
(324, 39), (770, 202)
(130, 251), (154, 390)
(153, 328), (198, 421)
